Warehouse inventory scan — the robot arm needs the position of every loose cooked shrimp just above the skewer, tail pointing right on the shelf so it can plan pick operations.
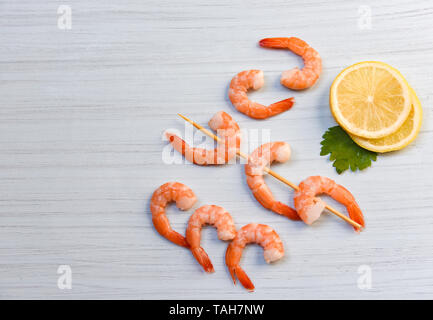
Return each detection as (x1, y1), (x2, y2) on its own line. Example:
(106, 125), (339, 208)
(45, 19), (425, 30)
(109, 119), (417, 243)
(229, 70), (294, 119)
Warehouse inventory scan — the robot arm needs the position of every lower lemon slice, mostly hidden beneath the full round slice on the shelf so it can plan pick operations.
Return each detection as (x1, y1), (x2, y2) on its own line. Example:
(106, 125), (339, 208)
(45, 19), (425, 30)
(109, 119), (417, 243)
(351, 89), (422, 152)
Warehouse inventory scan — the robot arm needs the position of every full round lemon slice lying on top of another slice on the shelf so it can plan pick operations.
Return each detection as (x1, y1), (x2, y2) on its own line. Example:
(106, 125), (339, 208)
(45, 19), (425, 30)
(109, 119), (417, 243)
(329, 61), (411, 139)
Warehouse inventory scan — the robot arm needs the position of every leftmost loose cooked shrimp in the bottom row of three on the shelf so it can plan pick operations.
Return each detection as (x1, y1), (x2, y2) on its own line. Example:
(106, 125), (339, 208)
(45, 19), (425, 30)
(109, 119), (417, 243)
(150, 182), (197, 247)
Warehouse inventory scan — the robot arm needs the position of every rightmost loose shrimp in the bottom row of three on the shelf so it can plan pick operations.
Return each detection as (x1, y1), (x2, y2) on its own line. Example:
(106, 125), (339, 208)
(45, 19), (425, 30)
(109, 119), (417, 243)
(226, 223), (284, 291)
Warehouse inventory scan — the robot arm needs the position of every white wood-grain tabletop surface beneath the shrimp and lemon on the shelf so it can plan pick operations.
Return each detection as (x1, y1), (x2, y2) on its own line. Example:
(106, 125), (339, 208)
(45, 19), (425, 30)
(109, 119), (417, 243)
(0, 0), (433, 299)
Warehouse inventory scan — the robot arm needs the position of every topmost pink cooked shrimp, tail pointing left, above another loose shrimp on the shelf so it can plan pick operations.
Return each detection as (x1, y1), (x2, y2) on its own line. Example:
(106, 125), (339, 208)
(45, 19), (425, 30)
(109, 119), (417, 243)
(259, 37), (322, 90)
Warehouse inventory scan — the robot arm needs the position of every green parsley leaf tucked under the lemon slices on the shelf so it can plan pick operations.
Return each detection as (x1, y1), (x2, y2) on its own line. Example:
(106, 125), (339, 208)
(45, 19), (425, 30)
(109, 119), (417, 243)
(320, 126), (377, 174)
